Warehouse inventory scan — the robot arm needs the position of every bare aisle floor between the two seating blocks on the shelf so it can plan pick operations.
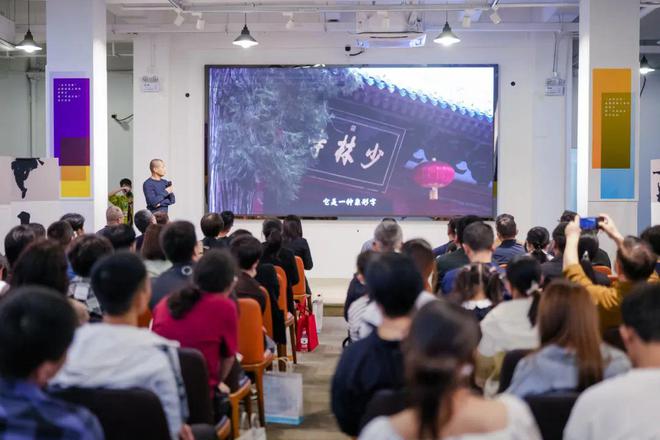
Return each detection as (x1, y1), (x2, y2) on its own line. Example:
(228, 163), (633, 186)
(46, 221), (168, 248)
(267, 316), (347, 440)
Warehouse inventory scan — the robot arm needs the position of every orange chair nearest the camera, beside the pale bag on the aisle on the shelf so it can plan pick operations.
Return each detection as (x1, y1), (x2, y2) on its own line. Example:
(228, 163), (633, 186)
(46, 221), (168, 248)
(238, 298), (273, 426)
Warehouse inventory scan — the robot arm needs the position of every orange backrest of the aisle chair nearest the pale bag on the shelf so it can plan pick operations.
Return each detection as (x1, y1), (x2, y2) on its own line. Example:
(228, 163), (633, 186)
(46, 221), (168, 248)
(238, 298), (265, 364)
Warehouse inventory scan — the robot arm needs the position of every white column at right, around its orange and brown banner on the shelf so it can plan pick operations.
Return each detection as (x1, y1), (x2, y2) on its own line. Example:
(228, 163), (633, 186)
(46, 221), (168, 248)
(577, 0), (639, 241)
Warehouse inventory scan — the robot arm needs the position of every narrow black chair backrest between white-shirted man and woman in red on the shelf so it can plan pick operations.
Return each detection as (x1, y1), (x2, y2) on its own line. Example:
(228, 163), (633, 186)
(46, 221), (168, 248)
(179, 348), (213, 424)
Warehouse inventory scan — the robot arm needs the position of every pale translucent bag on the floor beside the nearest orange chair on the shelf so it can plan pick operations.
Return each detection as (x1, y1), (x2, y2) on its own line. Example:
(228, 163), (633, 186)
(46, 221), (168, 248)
(264, 357), (303, 426)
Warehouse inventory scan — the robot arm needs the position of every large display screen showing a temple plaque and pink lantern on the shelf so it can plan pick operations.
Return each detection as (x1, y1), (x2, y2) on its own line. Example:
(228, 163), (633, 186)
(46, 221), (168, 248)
(206, 65), (497, 217)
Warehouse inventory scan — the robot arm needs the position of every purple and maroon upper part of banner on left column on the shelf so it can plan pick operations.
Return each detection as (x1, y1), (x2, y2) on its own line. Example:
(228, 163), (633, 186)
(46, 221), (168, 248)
(53, 78), (90, 166)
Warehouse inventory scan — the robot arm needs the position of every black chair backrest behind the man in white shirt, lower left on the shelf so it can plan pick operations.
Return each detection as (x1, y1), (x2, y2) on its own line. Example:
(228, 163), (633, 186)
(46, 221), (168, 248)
(51, 388), (171, 440)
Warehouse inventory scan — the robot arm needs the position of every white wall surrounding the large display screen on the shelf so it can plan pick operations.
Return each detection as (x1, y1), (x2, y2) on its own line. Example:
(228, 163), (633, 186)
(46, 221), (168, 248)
(134, 32), (570, 278)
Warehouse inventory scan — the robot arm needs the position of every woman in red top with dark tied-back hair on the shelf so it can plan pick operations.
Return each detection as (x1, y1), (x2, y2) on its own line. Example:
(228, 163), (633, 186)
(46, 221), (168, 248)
(152, 251), (240, 395)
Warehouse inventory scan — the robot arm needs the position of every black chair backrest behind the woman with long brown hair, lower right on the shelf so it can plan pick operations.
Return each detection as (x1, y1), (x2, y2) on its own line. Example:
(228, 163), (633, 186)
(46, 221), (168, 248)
(525, 391), (579, 440)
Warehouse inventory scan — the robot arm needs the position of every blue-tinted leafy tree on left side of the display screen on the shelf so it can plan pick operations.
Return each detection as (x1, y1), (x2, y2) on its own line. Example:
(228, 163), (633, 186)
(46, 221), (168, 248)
(208, 68), (362, 213)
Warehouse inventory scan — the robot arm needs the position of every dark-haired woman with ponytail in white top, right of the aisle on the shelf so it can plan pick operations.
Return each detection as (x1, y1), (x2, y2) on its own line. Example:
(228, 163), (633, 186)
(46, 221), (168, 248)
(475, 255), (542, 395)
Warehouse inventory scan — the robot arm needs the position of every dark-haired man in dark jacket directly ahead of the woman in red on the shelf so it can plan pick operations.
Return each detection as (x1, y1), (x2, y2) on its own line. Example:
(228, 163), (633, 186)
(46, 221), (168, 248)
(149, 221), (198, 309)
